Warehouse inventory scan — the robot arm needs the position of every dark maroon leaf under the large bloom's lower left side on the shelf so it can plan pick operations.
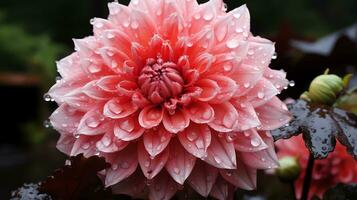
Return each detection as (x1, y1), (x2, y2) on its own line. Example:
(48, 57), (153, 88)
(40, 154), (111, 200)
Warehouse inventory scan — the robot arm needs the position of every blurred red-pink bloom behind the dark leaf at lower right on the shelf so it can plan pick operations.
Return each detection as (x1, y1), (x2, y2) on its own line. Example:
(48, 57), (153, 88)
(276, 135), (357, 199)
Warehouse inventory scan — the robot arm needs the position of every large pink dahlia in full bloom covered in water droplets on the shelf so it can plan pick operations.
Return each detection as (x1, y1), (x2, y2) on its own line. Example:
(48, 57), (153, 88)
(48, 0), (289, 199)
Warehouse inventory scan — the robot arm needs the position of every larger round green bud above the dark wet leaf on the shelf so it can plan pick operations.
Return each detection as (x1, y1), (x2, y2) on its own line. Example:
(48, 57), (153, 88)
(307, 74), (344, 105)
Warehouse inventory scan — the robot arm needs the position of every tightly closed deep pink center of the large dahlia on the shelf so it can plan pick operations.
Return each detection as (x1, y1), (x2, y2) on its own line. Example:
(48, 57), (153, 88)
(138, 58), (184, 104)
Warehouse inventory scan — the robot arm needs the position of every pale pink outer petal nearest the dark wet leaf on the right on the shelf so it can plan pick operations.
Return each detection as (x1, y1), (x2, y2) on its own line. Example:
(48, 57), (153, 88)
(255, 97), (291, 130)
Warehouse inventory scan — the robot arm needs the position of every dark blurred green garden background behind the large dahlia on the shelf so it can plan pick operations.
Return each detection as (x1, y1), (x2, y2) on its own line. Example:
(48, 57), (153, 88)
(0, 0), (357, 199)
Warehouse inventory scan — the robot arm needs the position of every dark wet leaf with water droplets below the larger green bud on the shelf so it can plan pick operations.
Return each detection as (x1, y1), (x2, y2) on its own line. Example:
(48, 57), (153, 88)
(272, 100), (357, 159)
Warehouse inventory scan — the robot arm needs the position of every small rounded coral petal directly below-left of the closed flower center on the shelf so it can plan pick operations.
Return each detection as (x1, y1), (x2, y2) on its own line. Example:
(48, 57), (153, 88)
(139, 106), (164, 129)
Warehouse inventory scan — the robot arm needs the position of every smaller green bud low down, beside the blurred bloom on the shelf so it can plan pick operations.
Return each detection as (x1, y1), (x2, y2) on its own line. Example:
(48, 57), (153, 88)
(275, 156), (300, 182)
